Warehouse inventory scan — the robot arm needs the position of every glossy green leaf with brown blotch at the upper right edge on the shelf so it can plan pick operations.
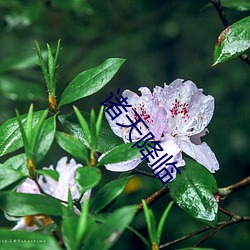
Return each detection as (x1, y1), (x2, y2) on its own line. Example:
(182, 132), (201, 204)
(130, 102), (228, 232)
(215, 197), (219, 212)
(213, 16), (250, 66)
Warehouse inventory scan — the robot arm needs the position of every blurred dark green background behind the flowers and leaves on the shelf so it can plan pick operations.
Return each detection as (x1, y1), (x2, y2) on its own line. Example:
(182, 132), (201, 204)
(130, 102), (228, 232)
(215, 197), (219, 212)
(0, 0), (250, 250)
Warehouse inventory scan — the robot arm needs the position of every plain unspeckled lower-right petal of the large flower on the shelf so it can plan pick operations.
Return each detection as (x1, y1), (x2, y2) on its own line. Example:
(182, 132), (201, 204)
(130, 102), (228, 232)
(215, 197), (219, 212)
(178, 140), (219, 173)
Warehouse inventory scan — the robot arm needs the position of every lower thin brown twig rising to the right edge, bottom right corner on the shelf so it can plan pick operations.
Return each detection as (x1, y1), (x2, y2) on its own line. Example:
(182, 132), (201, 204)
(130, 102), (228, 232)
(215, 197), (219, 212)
(194, 215), (250, 247)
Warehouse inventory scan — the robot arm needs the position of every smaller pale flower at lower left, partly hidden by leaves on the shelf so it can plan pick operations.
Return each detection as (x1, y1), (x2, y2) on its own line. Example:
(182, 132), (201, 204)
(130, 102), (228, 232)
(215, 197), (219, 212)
(12, 157), (90, 231)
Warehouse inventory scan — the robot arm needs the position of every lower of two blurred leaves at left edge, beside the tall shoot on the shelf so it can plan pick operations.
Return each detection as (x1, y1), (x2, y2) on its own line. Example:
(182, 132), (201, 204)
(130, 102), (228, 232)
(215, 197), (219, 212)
(0, 76), (46, 102)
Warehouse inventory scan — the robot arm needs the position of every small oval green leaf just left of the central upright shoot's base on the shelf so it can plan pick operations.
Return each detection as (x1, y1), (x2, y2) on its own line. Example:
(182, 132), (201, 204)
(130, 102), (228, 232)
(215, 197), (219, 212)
(56, 132), (89, 165)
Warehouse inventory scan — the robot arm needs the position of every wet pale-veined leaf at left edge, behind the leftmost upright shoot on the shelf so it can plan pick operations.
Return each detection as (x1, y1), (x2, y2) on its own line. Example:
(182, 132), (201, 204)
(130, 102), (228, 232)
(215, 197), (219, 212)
(0, 111), (44, 156)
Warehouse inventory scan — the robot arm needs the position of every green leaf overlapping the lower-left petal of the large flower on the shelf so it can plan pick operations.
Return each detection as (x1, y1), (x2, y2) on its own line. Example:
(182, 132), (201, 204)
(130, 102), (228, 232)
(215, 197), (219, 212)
(97, 142), (141, 166)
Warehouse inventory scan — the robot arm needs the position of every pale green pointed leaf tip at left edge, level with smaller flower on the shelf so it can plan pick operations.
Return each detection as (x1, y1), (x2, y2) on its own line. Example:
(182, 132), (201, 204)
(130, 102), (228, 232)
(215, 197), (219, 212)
(0, 164), (26, 190)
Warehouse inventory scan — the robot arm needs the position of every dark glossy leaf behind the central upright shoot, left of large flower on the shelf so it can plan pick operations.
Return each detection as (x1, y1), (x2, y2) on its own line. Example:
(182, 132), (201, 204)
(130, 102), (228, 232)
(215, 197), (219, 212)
(59, 113), (124, 153)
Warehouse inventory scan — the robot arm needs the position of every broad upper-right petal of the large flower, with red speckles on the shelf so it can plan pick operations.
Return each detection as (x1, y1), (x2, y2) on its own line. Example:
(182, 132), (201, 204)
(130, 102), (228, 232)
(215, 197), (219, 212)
(153, 79), (214, 136)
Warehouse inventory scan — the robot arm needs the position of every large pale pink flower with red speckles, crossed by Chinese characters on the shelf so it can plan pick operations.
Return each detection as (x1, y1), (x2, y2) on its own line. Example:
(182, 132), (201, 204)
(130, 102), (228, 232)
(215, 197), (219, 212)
(101, 79), (219, 178)
